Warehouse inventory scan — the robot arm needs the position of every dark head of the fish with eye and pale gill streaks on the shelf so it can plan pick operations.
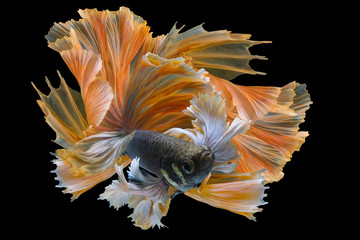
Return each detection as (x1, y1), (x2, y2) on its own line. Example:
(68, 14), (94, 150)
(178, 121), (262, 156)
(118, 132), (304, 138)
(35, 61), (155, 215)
(161, 145), (215, 192)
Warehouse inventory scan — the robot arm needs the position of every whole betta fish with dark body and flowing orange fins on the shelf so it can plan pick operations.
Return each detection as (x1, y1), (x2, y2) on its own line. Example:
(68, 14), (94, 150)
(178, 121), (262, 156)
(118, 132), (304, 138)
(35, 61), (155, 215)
(34, 7), (312, 229)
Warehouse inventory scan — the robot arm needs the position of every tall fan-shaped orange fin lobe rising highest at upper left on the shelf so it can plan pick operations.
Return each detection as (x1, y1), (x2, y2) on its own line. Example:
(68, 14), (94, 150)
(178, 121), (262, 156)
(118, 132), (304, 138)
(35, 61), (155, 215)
(46, 7), (158, 131)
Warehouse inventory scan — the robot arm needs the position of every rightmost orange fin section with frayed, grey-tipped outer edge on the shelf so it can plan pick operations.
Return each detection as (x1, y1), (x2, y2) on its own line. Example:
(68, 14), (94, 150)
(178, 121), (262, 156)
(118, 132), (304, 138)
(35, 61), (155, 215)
(234, 82), (312, 182)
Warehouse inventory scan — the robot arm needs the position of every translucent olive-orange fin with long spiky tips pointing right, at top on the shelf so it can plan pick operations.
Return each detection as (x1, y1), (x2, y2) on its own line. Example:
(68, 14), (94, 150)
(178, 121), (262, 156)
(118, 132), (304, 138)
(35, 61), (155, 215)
(157, 25), (270, 80)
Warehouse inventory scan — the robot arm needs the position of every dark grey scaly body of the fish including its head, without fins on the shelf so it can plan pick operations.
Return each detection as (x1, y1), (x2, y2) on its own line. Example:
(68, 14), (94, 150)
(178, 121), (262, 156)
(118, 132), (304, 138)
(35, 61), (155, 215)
(125, 130), (215, 192)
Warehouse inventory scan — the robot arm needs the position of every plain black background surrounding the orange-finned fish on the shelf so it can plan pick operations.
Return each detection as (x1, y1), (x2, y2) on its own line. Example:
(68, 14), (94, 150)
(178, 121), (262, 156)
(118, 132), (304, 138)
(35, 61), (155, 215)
(6, 0), (339, 236)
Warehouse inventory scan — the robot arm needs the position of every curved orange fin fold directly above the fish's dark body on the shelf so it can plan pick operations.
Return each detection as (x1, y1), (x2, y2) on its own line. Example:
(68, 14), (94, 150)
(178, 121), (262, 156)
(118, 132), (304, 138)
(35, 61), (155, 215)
(122, 53), (213, 132)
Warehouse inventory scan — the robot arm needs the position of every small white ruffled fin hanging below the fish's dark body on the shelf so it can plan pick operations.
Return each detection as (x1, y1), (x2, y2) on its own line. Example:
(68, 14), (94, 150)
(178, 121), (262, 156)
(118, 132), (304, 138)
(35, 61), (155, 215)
(99, 158), (172, 230)
